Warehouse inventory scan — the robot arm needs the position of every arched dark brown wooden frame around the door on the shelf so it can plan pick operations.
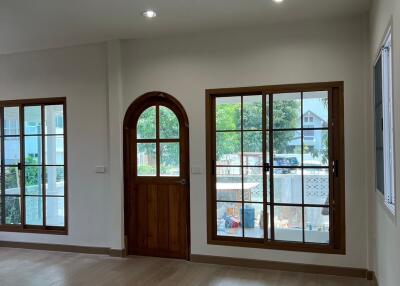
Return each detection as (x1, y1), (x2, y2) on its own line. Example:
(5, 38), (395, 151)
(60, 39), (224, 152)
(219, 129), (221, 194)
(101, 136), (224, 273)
(123, 91), (191, 260)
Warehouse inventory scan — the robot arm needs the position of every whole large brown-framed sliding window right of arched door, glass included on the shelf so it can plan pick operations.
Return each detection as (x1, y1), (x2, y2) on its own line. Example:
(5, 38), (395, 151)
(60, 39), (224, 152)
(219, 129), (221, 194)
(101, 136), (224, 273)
(206, 82), (345, 253)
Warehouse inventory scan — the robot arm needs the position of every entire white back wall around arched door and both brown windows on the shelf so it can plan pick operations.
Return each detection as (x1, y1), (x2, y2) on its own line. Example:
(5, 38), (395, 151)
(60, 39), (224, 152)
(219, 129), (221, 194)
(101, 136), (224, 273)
(0, 14), (369, 268)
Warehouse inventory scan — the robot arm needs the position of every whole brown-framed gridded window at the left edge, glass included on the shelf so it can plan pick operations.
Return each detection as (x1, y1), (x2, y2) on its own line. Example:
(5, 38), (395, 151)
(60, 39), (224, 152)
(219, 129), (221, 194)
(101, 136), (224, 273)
(0, 98), (67, 233)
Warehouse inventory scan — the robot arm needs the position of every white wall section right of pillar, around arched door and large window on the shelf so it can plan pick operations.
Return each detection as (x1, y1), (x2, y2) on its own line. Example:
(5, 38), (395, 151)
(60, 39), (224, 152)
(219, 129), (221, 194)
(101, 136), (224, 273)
(122, 17), (368, 268)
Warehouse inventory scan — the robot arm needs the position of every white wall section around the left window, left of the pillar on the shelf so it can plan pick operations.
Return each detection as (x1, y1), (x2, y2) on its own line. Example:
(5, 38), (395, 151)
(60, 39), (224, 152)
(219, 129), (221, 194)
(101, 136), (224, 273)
(0, 45), (109, 246)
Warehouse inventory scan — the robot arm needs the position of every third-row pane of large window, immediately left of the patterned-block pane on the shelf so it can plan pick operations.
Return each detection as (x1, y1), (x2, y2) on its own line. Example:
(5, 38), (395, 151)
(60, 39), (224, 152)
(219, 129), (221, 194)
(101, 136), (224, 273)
(274, 169), (303, 204)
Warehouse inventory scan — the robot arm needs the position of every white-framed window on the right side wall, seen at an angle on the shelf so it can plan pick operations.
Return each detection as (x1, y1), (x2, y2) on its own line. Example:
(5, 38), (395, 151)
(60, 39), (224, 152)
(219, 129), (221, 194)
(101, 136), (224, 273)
(374, 29), (395, 213)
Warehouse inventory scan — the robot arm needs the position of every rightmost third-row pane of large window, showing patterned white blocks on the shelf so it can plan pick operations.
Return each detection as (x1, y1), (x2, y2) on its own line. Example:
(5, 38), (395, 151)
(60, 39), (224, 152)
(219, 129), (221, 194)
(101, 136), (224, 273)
(304, 169), (329, 205)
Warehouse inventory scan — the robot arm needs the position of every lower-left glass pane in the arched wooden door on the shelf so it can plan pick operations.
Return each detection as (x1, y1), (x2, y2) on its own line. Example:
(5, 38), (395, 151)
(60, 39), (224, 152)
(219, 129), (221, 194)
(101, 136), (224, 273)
(137, 143), (157, 176)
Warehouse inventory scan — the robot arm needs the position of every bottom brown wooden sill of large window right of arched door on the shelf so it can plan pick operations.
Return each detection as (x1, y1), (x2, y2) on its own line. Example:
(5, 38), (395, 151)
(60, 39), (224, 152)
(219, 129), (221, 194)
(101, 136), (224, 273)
(207, 237), (346, 255)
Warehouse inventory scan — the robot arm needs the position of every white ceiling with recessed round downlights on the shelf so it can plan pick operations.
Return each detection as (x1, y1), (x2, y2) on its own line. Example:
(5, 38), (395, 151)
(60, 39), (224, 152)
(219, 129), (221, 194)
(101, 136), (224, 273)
(0, 0), (370, 53)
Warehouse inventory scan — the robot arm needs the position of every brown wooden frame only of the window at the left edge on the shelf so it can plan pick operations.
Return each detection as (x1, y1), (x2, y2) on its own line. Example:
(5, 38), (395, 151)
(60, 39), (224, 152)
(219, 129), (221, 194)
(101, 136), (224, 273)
(0, 97), (68, 235)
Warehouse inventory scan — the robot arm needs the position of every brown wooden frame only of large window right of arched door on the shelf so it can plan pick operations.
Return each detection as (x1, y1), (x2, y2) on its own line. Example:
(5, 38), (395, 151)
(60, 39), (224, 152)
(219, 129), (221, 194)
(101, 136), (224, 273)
(205, 82), (346, 255)
